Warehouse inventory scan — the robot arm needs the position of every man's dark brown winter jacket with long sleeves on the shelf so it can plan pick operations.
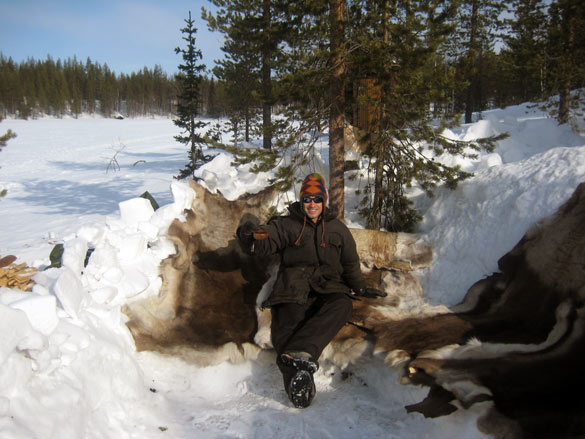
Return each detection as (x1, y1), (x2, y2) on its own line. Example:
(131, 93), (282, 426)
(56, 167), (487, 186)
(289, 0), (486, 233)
(248, 202), (365, 307)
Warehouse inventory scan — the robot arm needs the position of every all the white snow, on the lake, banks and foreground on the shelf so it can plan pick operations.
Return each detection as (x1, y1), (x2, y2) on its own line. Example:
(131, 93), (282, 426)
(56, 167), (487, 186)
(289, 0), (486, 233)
(0, 105), (585, 439)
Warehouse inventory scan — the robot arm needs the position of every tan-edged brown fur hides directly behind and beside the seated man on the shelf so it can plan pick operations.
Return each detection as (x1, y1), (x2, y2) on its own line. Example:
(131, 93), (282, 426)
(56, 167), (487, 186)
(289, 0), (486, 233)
(124, 181), (432, 366)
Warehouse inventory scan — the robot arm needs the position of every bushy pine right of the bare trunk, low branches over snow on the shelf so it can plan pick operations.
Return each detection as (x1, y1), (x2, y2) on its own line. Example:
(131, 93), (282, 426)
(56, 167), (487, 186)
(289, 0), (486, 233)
(348, 0), (506, 231)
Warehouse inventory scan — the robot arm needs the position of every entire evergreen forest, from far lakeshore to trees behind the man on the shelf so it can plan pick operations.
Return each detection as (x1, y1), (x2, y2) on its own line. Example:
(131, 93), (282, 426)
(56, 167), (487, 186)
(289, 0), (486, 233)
(0, 0), (585, 231)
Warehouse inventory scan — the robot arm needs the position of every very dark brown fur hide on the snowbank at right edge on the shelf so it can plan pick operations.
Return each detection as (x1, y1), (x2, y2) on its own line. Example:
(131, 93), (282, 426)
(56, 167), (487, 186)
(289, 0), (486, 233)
(408, 184), (585, 438)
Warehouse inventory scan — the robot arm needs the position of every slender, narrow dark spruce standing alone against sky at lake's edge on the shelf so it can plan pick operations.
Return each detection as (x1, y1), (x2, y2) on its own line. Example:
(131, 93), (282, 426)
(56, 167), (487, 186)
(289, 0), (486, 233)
(173, 11), (212, 179)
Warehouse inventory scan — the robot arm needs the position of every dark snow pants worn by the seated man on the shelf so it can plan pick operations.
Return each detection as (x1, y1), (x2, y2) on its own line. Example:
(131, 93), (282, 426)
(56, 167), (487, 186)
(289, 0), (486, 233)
(271, 293), (353, 387)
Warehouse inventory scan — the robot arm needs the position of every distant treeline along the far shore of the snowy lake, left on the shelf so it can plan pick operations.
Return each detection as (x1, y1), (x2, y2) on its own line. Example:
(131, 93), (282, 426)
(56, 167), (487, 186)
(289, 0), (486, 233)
(0, 54), (221, 119)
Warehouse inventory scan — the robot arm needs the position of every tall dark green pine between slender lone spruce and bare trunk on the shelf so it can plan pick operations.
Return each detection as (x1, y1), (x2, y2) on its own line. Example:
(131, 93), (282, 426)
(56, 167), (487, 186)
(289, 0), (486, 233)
(203, 0), (295, 149)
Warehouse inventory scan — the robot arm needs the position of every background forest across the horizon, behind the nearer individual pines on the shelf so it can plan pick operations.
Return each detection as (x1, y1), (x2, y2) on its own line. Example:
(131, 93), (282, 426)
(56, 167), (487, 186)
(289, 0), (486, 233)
(0, 0), (585, 124)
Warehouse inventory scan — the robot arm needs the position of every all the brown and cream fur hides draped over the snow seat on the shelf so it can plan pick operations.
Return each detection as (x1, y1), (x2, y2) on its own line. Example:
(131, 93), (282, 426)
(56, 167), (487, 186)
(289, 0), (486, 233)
(125, 182), (585, 438)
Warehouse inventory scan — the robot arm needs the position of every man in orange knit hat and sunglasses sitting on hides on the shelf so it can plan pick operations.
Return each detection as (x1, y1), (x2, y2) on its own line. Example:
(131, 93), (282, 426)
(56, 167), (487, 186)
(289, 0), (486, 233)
(237, 174), (386, 408)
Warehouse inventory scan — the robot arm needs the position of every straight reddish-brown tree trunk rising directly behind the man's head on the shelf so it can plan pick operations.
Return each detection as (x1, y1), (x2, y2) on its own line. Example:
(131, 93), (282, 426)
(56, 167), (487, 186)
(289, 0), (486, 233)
(329, 0), (345, 220)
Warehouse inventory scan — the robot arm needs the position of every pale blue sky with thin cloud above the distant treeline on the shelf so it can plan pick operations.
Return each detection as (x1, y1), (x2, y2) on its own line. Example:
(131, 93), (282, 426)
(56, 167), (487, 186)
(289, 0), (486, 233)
(0, 0), (222, 74)
